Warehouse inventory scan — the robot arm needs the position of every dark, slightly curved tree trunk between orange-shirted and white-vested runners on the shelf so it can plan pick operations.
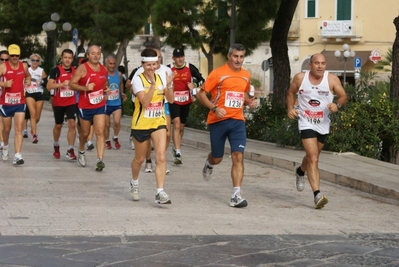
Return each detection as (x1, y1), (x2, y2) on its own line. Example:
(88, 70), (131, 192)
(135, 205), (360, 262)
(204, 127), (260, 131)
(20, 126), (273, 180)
(270, 0), (299, 106)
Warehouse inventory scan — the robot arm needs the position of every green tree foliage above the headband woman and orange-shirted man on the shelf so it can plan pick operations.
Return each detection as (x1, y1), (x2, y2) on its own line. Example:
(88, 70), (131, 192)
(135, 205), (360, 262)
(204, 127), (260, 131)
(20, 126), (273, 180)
(151, 0), (279, 72)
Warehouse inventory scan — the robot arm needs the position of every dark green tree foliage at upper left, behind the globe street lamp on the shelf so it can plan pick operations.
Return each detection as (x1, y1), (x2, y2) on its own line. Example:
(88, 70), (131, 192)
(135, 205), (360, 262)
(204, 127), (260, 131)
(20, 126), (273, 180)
(0, 0), (153, 67)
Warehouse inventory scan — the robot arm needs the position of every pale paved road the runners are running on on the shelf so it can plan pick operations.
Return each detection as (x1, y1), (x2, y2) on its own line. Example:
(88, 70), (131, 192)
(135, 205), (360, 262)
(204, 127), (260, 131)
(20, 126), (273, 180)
(0, 110), (399, 266)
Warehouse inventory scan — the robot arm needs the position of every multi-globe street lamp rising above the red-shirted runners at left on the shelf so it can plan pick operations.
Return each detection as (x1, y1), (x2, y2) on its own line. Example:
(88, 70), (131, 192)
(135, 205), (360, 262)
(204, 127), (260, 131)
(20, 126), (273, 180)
(42, 13), (72, 66)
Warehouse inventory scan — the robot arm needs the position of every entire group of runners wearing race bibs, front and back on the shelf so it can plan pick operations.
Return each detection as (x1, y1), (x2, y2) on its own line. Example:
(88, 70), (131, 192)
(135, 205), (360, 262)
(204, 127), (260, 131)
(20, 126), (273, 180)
(0, 44), (347, 208)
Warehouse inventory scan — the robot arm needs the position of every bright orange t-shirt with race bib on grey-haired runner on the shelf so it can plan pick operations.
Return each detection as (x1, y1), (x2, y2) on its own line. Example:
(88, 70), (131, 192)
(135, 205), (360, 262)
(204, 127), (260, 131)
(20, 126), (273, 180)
(204, 64), (251, 124)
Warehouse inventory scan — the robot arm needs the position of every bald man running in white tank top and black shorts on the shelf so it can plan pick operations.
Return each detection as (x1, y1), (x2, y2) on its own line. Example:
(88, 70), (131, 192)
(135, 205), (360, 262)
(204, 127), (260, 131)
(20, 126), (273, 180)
(287, 54), (347, 209)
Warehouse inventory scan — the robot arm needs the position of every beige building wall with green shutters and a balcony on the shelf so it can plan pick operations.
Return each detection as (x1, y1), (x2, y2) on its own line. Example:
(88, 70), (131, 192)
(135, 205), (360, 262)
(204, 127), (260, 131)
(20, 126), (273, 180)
(296, 0), (399, 82)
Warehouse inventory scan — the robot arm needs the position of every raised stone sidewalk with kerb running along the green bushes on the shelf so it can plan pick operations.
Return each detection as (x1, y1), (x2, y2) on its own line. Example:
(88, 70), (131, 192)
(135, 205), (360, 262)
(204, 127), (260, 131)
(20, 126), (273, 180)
(118, 105), (399, 200)
